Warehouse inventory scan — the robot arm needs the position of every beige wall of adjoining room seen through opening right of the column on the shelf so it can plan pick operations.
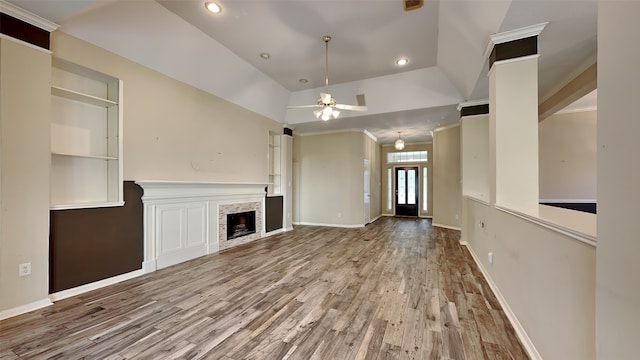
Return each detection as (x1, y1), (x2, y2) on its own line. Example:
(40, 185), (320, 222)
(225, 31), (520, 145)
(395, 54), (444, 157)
(538, 110), (598, 200)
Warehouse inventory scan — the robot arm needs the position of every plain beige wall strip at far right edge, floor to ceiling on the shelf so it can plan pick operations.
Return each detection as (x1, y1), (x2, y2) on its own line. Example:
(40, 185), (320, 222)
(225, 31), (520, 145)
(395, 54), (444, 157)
(596, 1), (640, 360)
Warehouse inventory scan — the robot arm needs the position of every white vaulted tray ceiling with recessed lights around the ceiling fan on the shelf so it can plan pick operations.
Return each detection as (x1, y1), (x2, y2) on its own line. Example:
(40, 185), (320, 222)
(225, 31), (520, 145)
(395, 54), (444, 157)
(9, 0), (597, 143)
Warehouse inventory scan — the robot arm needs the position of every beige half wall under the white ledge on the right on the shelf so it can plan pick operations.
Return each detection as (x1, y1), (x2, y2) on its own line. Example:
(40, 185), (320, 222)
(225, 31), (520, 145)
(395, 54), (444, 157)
(464, 199), (596, 360)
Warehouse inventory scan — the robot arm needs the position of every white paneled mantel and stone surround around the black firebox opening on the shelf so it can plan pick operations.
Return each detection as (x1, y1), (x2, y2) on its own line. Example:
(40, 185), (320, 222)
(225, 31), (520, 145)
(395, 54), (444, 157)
(136, 181), (266, 272)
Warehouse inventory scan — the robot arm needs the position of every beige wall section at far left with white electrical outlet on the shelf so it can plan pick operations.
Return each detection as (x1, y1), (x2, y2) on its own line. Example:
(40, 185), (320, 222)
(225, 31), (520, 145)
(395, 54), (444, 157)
(0, 38), (51, 317)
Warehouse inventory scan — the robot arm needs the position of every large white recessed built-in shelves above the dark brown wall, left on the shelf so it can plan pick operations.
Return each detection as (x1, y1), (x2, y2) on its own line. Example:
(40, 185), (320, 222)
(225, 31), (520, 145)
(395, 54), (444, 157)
(51, 58), (123, 209)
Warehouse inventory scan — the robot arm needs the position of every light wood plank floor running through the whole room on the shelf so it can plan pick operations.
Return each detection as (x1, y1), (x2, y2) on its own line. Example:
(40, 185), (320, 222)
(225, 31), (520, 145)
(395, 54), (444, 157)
(0, 218), (528, 360)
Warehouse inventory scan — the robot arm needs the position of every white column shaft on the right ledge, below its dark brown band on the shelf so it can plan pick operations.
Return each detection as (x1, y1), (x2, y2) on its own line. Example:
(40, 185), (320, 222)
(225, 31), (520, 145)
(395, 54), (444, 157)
(489, 55), (539, 215)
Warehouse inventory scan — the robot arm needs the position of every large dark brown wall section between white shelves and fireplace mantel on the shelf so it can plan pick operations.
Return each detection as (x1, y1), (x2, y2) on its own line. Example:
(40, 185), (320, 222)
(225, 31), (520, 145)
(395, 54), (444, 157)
(49, 181), (144, 293)
